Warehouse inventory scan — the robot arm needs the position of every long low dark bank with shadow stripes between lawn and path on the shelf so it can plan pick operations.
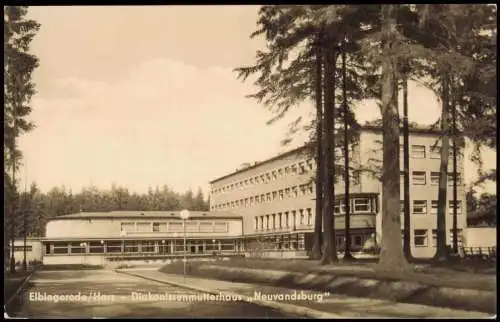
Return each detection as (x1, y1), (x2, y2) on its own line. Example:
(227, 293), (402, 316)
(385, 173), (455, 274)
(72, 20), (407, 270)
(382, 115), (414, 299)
(191, 264), (496, 314)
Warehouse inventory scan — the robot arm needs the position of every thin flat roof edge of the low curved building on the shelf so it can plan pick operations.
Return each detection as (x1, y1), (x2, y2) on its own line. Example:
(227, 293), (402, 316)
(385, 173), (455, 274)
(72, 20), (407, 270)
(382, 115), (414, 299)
(49, 210), (243, 221)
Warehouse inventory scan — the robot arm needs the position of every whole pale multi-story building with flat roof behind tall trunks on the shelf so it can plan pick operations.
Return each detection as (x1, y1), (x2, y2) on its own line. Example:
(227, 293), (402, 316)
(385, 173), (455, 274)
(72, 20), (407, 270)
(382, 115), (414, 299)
(210, 126), (466, 257)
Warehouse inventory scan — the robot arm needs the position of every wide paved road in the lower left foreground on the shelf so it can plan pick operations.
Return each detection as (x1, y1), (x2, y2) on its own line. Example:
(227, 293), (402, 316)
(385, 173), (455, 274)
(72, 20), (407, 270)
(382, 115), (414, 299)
(8, 270), (294, 318)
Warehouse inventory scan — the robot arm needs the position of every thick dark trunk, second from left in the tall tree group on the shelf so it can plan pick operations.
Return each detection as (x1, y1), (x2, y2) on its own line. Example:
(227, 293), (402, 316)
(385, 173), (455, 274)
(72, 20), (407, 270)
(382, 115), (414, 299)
(321, 43), (337, 265)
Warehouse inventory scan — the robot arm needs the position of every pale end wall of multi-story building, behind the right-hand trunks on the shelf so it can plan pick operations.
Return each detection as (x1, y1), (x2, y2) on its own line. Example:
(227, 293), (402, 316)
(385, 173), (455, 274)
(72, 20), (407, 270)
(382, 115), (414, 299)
(360, 131), (467, 257)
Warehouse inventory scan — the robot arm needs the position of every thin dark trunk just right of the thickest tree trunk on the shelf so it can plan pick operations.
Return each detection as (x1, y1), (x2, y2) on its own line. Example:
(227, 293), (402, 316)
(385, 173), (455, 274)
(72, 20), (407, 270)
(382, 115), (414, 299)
(403, 74), (412, 261)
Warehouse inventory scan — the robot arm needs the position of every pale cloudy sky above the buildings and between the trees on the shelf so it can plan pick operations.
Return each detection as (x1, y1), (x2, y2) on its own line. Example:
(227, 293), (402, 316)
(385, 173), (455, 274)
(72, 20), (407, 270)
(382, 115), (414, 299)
(20, 5), (496, 193)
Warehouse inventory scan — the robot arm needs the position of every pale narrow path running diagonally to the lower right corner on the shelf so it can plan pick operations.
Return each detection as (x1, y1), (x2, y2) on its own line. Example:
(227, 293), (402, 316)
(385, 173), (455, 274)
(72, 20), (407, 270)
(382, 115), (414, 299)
(122, 270), (489, 318)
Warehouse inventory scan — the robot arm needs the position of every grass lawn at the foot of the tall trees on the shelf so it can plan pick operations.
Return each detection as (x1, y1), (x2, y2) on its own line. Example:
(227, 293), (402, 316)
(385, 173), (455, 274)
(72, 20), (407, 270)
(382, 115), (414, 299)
(160, 258), (496, 291)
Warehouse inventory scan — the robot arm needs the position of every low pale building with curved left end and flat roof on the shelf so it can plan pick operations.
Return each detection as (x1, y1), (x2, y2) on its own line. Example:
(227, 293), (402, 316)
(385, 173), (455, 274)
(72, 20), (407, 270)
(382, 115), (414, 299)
(42, 211), (243, 265)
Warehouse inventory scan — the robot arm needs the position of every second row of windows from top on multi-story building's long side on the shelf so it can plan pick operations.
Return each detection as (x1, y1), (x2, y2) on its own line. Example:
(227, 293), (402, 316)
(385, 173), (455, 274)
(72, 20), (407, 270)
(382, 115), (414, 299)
(212, 183), (315, 210)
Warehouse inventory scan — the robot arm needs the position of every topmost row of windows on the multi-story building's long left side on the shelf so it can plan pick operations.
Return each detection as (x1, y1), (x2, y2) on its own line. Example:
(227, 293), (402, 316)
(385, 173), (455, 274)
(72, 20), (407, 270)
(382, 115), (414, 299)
(212, 159), (315, 194)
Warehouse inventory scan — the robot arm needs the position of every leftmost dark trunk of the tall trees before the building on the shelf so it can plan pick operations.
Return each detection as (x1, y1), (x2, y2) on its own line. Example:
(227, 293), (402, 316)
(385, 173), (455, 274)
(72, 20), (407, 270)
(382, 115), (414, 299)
(311, 31), (324, 259)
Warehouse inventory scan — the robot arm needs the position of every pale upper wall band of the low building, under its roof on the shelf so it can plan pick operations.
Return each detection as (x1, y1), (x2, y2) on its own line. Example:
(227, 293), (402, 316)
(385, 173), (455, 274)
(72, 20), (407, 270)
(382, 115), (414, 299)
(46, 218), (242, 239)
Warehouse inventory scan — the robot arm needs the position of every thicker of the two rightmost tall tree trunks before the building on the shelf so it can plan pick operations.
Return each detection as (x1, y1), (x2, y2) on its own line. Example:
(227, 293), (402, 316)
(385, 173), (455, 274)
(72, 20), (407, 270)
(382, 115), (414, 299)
(436, 74), (450, 260)
